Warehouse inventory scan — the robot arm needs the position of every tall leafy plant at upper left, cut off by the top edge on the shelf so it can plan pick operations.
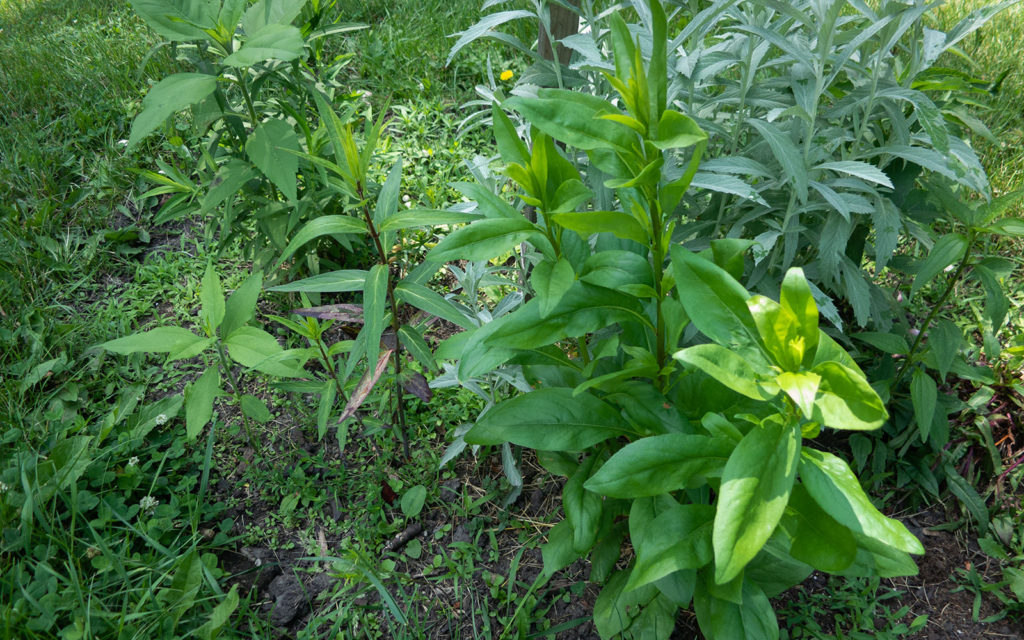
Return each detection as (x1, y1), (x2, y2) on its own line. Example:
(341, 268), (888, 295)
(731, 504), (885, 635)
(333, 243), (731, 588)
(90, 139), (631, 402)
(128, 0), (361, 269)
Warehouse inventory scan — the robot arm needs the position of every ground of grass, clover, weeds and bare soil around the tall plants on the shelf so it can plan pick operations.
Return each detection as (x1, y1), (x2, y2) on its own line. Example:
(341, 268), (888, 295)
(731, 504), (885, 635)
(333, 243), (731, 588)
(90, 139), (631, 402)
(0, 0), (1024, 638)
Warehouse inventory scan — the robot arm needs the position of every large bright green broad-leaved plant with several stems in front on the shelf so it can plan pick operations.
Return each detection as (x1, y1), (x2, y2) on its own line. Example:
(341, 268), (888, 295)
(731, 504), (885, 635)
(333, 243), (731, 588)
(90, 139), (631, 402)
(430, 1), (923, 638)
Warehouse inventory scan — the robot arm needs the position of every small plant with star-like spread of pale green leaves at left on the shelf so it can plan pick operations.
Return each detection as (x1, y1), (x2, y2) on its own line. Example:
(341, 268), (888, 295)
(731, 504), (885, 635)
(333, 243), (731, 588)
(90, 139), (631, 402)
(99, 265), (311, 451)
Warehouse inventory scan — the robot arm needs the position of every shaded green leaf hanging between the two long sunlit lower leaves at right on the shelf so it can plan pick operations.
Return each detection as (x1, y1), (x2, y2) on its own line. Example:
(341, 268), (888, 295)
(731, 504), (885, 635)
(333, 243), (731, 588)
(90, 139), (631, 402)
(786, 482), (857, 572)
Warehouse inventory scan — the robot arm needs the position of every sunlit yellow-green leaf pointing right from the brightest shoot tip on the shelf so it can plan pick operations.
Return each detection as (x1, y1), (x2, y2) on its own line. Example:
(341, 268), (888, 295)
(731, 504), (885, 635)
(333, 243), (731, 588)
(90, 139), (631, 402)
(812, 362), (889, 430)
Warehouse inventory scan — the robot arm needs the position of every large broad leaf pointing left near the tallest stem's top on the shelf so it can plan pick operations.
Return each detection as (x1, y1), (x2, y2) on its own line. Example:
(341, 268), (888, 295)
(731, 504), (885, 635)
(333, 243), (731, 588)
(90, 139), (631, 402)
(503, 89), (636, 153)
